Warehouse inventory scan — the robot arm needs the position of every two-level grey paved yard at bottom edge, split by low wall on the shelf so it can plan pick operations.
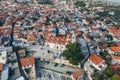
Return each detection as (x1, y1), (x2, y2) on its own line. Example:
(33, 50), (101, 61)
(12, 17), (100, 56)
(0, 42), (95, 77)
(36, 61), (79, 80)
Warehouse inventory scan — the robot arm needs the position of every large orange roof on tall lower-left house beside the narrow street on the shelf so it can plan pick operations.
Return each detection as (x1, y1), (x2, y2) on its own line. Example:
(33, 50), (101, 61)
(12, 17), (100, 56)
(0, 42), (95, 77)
(20, 57), (35, 66)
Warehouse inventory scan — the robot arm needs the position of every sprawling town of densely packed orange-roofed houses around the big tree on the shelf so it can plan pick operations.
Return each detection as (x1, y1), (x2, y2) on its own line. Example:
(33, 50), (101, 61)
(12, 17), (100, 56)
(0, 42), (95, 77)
(0, 0), (120, 80)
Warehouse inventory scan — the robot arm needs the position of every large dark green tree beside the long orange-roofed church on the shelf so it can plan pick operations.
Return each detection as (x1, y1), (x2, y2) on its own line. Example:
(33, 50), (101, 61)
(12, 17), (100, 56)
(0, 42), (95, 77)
(62, 42), (83, 65)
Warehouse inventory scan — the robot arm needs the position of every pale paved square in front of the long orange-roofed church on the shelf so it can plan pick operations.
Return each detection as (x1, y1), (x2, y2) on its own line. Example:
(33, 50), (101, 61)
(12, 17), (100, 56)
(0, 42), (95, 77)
(27, 45), (59, 59)
